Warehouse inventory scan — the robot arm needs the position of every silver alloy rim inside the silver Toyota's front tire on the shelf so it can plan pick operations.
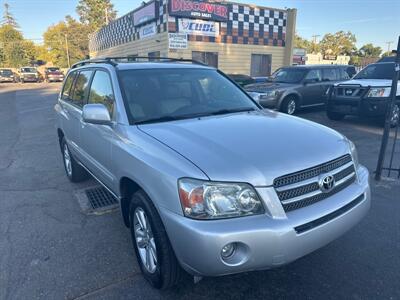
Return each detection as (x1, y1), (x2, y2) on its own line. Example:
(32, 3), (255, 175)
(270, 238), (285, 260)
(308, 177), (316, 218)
(133, 207), (157, 273)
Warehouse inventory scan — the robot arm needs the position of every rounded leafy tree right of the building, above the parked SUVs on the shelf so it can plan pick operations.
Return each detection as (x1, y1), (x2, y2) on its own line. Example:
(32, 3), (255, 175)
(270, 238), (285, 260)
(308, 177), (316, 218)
(320, 31), (357, 56)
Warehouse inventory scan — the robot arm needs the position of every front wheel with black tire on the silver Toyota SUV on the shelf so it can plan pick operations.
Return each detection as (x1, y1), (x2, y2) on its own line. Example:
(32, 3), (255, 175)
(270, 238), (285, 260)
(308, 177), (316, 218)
(129, 191), (182, 289)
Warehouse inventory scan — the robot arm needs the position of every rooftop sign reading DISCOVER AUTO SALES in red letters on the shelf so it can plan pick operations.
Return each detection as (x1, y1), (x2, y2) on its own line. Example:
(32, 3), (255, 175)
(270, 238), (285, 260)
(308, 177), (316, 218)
(169, 0), (228, 21)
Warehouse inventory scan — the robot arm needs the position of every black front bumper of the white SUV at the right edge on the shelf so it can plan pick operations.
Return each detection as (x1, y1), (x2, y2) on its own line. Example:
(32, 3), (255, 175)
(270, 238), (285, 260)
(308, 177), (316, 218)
(328, 97), (390, 117)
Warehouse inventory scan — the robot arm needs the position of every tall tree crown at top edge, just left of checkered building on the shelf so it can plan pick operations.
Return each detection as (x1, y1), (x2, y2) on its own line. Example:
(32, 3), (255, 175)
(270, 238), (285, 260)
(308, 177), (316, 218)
(76, 0), (117, 32)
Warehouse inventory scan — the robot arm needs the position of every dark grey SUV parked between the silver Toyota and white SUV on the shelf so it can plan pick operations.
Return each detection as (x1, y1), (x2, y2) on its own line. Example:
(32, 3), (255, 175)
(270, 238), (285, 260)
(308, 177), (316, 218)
(246, 65), (350, 115)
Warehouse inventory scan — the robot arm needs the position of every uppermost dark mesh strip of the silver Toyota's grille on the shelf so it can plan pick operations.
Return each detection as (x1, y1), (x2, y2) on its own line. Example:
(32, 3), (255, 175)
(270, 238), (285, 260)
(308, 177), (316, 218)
(274, 154), (351, 188)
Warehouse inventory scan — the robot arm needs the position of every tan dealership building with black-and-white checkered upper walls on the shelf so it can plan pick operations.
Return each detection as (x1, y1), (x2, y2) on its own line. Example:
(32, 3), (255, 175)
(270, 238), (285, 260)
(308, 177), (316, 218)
(89, 0), (296, 76)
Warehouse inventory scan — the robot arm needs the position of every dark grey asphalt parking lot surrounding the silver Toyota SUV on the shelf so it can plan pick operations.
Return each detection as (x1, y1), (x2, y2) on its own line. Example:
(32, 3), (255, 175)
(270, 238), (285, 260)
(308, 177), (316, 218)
(0, 84), (400, 299)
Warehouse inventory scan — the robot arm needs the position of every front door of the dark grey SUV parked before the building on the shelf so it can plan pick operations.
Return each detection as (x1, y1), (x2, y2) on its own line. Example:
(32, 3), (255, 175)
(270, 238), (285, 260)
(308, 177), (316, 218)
(299, 69), (322, 106)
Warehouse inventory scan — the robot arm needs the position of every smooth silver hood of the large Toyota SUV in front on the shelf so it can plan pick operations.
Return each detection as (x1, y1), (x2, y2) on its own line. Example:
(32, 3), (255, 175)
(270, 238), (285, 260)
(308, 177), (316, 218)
(139, 111), (349, 186)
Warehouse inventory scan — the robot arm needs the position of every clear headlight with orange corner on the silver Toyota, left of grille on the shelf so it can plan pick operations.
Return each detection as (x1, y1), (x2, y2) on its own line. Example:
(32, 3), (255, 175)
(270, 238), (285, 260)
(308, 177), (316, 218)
(178, 178), (264, 219)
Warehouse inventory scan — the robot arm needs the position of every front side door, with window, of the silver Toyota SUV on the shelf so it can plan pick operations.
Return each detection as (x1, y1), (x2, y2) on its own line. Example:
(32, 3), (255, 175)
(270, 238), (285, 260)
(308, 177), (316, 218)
(80, 69), (115, 188)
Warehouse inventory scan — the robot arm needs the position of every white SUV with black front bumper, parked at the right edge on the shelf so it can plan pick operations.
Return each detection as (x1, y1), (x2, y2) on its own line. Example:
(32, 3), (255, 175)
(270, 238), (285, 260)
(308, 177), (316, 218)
(327, 62), (400, 126)
